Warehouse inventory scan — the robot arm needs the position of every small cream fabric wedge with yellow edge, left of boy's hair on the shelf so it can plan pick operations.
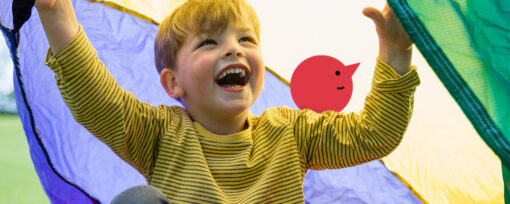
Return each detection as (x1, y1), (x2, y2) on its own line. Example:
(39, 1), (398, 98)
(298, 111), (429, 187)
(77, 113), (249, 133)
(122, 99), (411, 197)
(89, 0), (185, 24)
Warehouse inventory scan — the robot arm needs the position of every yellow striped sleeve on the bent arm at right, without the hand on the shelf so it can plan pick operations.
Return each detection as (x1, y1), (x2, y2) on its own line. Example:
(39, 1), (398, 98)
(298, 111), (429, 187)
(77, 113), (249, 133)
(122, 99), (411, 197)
(289, 59), (420, 170)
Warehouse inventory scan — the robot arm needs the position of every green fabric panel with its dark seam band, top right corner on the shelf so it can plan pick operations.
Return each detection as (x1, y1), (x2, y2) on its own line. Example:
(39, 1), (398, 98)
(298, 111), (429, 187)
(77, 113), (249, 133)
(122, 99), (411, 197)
(388, 0), (510, 167)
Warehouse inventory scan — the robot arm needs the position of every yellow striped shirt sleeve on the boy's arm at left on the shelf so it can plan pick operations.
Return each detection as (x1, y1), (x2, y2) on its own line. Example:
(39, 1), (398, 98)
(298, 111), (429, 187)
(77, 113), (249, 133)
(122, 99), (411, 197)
(45, 26), (167, 178)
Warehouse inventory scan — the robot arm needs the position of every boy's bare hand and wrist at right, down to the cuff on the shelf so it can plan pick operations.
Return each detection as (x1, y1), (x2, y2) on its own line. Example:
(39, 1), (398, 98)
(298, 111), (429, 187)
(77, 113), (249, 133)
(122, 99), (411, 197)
(363, 4), (413, 75)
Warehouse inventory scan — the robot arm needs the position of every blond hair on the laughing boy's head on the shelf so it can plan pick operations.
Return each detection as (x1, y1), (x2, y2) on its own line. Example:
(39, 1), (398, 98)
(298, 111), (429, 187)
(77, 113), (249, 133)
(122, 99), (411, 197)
(154, 0), (260, 73)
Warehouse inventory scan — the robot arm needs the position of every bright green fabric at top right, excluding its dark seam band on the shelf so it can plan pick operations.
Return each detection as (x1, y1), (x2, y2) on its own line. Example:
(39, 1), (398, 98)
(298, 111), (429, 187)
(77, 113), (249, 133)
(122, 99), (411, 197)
(408, 0), (510, 150)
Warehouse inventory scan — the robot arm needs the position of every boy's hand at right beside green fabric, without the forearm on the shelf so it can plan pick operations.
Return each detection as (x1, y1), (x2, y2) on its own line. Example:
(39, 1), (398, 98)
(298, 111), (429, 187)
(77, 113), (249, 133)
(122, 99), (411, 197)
(363, 4), (413, 50)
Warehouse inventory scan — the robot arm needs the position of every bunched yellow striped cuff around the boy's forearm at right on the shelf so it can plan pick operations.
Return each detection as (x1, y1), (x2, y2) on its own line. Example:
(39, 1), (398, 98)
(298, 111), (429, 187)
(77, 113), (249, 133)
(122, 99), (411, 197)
(372, 58), (420, 92)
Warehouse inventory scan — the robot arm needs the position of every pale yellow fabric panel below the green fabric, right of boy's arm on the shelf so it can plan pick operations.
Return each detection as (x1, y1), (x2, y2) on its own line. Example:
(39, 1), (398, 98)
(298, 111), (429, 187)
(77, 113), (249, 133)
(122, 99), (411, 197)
(383, 53), (504, 204)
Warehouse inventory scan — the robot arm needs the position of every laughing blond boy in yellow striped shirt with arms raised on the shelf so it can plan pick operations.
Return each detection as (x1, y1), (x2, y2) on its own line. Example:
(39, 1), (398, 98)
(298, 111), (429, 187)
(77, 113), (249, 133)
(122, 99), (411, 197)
(36, 0), (419, 203)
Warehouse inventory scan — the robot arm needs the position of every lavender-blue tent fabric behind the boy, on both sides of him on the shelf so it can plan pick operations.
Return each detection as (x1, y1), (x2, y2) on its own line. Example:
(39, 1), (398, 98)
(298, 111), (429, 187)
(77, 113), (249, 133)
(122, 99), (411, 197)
(0, 0), (420, 203)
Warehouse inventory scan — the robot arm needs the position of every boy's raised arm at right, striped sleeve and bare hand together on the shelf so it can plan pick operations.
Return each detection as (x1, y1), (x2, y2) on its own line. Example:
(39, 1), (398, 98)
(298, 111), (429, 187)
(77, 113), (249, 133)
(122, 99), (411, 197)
(293, 5), (420, 169)
